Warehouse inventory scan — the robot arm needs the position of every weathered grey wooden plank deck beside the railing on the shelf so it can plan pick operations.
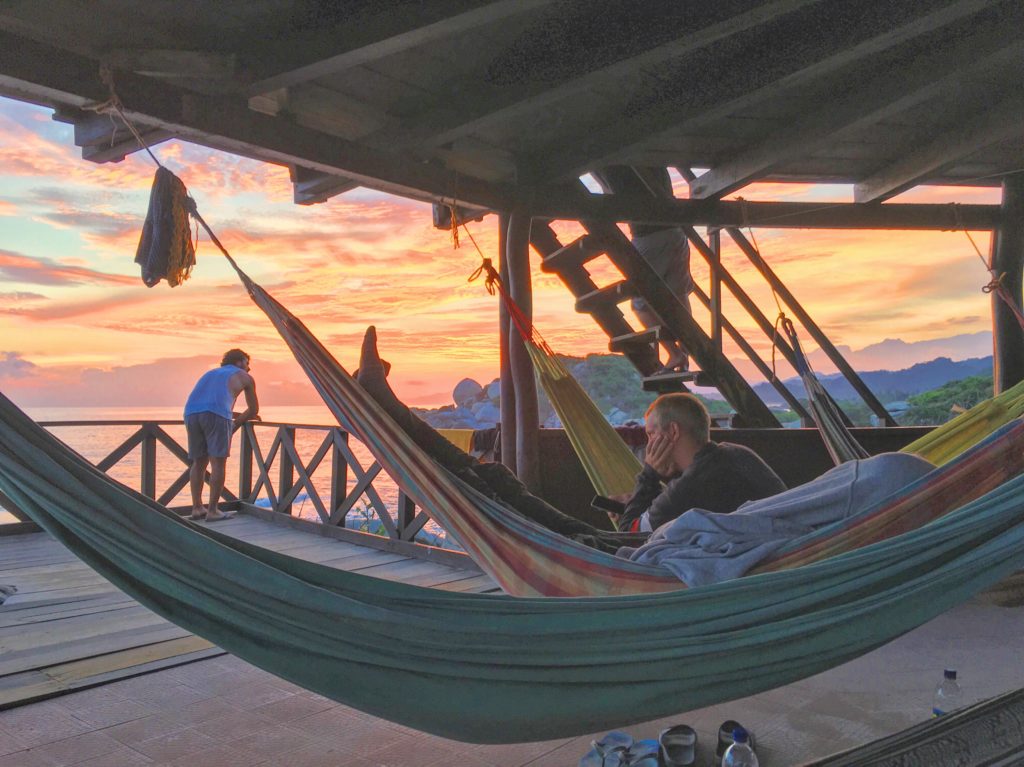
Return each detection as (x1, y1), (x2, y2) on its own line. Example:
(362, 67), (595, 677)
(0, 514), (498, 709)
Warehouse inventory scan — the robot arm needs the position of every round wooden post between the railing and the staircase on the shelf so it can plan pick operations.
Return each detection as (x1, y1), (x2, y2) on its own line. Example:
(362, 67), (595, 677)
(505, 211), (541, 493)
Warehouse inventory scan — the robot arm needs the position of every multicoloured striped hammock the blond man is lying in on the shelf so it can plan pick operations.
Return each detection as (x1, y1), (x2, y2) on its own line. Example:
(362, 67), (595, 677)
(232, 261), (1024, 597)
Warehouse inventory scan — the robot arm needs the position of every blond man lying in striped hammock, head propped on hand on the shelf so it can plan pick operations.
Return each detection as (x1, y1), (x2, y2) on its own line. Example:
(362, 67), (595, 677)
(355, 327), (785, 553)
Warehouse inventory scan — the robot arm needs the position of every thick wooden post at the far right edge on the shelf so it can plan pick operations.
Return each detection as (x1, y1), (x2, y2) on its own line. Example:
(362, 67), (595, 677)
(991, 175), (1024, 393)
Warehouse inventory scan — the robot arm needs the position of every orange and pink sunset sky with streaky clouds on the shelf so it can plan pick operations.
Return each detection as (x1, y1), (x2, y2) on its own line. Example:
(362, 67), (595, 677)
(0, 98), (998, 413)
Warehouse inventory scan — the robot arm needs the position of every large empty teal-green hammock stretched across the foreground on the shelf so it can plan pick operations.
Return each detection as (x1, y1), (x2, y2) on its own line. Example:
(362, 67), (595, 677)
(0, 389), (1024, 742)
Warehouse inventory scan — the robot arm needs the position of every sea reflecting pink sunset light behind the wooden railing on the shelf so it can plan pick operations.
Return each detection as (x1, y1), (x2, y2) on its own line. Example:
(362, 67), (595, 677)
(0, 406), (444, 545)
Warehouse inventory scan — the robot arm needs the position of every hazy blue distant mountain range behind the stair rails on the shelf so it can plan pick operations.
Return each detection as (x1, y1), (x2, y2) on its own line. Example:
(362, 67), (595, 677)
(754, 356), (992, 404)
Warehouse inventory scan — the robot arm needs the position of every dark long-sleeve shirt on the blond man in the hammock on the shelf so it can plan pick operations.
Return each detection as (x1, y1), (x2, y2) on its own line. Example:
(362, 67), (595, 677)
(620, 442), (785, 529)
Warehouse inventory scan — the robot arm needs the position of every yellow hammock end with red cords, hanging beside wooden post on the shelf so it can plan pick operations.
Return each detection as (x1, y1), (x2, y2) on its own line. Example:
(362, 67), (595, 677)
(470, 258), (643, 498)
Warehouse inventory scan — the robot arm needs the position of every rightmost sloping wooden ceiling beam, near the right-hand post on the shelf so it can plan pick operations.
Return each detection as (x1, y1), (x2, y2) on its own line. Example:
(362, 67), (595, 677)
(853, 95), (1024, 203)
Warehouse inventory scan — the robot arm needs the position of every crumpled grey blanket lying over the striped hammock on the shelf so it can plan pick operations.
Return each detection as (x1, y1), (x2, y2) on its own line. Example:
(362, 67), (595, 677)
(618, 453), (935, 586)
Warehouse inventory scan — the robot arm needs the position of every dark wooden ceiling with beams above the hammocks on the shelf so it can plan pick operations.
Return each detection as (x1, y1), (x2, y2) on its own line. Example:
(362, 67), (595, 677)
(0, 0), (1024, 213)
